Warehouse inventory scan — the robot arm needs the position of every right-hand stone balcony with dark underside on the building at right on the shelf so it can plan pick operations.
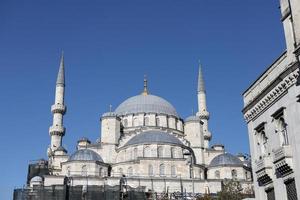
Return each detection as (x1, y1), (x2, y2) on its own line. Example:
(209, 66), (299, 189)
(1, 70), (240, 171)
(273, 145), (293, 177)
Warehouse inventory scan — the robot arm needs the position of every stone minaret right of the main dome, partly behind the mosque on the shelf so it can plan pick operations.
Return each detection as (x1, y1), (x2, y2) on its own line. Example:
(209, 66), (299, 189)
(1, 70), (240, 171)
(196, 64), (211, 148)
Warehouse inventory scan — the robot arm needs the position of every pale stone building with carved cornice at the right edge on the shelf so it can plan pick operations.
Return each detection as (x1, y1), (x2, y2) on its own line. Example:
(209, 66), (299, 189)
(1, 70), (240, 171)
(243, 0), (300, 200)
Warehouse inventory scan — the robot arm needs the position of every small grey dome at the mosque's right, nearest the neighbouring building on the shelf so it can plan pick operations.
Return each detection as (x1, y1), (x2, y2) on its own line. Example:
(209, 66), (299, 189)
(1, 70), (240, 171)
(209, 153), (243, 167)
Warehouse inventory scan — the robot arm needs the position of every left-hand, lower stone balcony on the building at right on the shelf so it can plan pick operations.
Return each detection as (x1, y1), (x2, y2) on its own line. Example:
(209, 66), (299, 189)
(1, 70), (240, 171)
(255, 156), (273, 186)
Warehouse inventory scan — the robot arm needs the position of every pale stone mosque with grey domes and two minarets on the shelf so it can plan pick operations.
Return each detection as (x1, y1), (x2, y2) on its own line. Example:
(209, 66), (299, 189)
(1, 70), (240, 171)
(22, 56), (252, 197)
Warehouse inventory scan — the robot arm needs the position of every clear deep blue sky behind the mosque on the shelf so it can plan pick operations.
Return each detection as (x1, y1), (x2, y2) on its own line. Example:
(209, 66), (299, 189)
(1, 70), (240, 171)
(0, 0), (285, 199)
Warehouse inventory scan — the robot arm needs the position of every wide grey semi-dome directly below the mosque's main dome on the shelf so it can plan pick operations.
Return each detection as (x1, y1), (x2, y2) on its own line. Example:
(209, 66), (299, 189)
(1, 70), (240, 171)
(124, 131), (183, 147)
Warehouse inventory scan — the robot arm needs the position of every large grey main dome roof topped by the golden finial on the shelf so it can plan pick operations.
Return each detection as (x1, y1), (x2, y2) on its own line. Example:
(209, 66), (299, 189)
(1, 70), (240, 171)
(115, 94), (178, 117)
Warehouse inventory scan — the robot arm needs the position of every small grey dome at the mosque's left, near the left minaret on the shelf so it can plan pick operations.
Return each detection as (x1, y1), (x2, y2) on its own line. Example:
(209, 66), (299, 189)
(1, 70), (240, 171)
(69, 149), (103, 162)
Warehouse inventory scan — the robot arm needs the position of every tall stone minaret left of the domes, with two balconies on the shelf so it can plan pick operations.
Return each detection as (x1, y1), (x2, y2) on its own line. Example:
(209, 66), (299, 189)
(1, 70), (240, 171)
(49, 53), (66, 152)
